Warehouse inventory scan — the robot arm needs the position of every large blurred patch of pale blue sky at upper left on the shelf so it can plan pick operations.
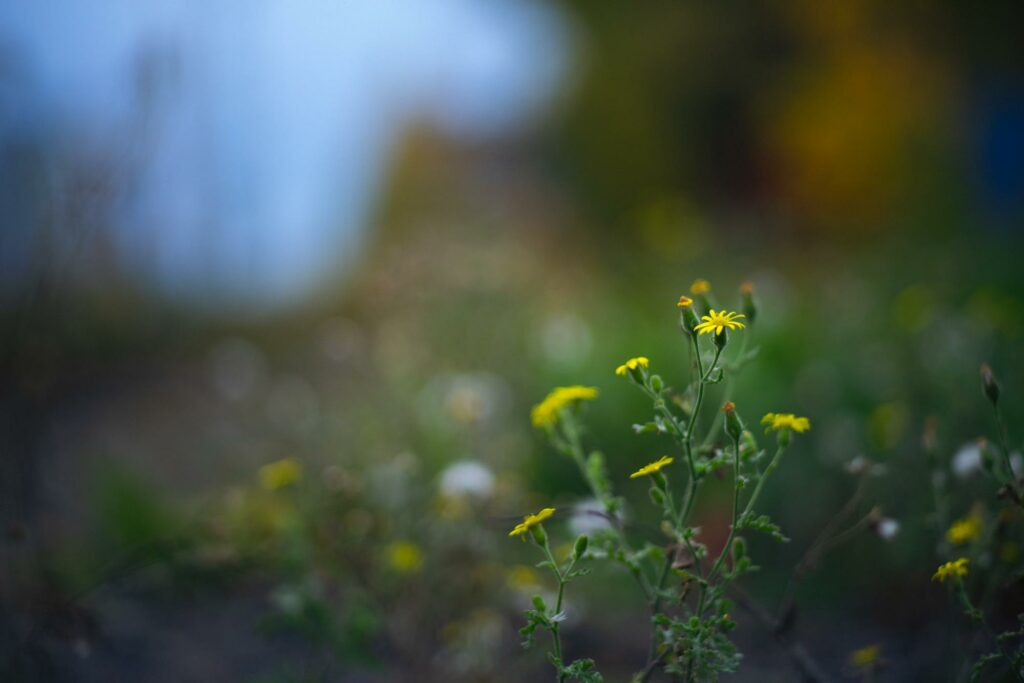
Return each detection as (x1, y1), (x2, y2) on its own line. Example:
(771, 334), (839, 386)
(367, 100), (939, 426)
(0, 0), (571, 306)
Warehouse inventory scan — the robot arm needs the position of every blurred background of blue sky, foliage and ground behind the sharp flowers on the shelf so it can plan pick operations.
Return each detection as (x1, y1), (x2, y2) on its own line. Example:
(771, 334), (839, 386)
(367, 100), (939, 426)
(0, 0), (1024, 682)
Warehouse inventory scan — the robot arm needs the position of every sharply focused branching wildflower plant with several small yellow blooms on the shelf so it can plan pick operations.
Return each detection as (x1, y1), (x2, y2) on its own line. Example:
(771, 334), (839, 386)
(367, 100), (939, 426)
(510, 280), (811, 683)
